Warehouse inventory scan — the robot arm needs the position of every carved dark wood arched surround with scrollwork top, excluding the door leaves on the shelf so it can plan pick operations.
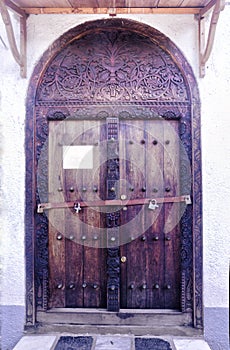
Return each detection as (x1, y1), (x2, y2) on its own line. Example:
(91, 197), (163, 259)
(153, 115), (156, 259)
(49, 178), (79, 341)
(26, 19), (202, 328)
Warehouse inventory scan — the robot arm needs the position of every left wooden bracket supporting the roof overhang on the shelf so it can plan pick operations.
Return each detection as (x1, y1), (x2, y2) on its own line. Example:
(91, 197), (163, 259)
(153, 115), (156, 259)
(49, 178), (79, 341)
(0, 0), (27, 78)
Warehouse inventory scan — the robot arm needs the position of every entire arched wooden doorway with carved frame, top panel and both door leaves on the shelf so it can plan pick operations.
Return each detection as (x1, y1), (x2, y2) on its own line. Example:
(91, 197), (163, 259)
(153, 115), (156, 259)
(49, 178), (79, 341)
(25, 19), (202, 327)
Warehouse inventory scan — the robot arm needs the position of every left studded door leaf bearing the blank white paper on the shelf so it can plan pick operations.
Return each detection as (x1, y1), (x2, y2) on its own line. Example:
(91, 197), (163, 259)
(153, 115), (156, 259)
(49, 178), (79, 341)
(47, 120), (106, 308)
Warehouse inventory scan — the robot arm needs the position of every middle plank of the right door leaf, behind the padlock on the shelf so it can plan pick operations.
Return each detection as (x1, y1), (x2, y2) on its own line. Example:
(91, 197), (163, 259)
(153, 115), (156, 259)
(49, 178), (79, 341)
(145, 120), (165, 309)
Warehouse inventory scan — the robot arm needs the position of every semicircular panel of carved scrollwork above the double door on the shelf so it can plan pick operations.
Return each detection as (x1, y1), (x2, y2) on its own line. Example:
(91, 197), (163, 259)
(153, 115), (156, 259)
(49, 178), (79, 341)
(36, 29), (189, 105)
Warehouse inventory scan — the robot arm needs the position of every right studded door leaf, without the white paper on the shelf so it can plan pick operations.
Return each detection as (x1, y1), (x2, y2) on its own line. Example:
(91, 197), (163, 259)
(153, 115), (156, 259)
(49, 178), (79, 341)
(120, 120), (181, 309)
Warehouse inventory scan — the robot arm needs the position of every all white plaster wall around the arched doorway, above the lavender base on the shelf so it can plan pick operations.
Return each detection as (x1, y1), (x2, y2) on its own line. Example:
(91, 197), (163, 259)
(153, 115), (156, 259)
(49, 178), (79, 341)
(0, 7), (230, 314)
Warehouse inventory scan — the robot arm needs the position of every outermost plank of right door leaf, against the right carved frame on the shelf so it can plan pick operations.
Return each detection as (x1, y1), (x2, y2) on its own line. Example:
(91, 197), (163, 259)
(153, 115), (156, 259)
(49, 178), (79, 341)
(163, 121), (181, 308)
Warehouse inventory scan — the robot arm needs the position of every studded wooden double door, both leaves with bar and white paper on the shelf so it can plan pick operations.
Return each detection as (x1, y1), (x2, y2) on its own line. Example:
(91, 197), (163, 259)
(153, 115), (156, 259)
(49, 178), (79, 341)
(47, 118), (181, 309)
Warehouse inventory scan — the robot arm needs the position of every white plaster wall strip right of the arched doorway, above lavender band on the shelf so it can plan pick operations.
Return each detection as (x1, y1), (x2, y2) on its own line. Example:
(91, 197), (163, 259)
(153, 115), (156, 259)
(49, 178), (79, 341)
(199, 6), (230, 307)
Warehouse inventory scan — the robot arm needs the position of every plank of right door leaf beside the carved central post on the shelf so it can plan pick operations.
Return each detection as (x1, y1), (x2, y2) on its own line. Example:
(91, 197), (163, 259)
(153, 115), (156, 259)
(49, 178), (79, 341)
(120, 121), (147, 308)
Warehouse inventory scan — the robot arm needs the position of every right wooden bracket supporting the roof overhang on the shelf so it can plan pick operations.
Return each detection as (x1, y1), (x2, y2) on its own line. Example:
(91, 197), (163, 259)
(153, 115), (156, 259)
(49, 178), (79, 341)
(195, 0), (225, 78)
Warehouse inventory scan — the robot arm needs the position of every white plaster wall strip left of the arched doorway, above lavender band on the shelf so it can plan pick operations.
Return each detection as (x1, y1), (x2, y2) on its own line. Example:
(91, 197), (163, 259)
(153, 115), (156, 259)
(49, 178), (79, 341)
(0, 12), (28, 305)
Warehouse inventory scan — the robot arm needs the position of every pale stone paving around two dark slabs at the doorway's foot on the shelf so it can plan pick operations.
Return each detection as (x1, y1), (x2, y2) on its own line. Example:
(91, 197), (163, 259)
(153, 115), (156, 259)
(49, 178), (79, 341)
(13, 333), (211, 350)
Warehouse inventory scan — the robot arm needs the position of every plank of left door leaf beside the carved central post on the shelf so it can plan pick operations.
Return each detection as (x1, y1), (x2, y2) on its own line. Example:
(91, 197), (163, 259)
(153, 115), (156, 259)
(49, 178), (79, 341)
(81, 121), (107, 307)
